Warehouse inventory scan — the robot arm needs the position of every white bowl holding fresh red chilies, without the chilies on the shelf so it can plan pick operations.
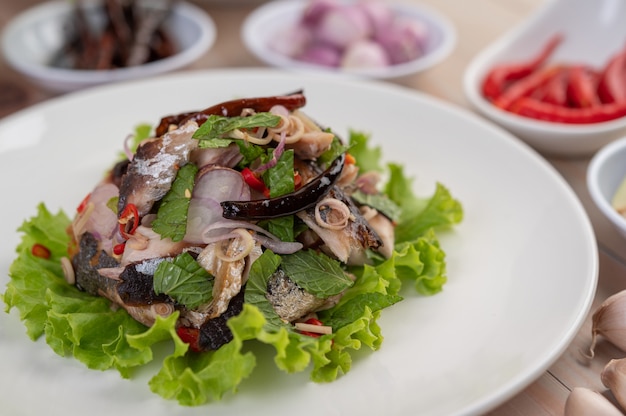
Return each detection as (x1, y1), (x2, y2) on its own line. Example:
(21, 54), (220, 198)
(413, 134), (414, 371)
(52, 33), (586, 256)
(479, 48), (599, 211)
(463, 0), (626, 156)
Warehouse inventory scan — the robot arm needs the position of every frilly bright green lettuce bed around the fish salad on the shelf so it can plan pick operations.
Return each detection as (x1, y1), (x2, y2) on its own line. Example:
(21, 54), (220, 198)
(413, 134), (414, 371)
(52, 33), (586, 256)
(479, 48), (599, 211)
(2, 124), (463, 406)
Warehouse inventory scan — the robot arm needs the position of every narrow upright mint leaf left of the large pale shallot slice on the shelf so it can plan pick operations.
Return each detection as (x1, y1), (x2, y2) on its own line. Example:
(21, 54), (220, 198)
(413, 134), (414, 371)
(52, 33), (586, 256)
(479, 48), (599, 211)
(152, 163), (198, 241)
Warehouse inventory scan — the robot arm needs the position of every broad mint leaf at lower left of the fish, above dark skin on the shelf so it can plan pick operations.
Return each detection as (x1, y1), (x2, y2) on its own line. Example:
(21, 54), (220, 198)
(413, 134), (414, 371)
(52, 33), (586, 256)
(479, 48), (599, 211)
(153, 252), (213, 309)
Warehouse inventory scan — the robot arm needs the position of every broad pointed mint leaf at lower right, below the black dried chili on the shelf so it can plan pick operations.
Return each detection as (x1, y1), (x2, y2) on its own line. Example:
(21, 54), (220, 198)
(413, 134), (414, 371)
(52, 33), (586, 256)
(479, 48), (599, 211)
(281, 250), (353, 299)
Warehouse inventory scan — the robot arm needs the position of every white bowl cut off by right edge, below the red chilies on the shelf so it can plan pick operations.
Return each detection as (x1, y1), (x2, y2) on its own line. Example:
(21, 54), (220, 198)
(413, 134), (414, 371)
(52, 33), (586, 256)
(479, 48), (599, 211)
(587, 137), (626, 238)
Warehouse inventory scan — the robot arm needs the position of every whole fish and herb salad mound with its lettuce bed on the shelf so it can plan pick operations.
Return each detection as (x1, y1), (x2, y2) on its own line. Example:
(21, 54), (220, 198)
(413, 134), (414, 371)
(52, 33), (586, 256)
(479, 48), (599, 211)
(3, 93), (463, 406)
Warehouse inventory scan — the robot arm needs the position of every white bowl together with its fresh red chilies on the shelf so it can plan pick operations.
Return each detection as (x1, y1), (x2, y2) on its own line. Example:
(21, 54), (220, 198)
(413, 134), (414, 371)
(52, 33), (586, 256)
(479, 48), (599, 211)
(464, 0), (626, 156)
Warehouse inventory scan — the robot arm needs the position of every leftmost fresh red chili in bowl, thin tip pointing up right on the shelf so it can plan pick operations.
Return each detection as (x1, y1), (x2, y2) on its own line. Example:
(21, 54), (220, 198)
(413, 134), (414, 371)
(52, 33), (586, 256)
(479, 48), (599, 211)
(483, 34), (563, 100)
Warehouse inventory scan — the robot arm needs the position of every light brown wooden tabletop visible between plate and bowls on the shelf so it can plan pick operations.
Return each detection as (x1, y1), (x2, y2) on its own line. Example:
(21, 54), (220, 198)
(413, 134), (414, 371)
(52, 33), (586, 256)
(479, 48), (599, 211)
(0, 0), (626, 416)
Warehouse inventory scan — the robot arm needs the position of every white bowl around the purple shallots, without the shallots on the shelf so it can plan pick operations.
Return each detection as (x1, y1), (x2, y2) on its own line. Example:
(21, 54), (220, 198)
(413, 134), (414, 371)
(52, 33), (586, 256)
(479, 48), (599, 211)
(242, 0), (456, 79)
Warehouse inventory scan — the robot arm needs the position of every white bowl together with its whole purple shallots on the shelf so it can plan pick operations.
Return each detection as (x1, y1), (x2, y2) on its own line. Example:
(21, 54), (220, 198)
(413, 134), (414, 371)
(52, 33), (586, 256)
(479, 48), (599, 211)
(242, 0), (456, 79)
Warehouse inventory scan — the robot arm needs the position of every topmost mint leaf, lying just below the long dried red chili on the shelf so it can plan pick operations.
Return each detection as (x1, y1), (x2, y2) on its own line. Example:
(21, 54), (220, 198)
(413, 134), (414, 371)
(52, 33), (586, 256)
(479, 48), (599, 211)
(193, 113), (281, 148)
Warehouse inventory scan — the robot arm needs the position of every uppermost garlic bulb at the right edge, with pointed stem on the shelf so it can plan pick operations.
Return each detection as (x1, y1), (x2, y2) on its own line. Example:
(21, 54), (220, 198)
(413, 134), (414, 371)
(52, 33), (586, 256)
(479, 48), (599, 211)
(589, 290), (626, 358)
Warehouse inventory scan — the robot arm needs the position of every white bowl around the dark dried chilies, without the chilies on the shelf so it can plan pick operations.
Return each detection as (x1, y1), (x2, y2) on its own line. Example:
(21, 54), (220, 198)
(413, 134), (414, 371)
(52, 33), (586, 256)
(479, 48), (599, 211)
(2, 1), (215, 92)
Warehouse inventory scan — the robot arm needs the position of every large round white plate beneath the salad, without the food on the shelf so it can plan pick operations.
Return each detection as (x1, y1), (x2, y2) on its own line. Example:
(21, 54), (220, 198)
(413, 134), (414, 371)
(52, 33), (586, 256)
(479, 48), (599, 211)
(0, 69), (598, 416)
